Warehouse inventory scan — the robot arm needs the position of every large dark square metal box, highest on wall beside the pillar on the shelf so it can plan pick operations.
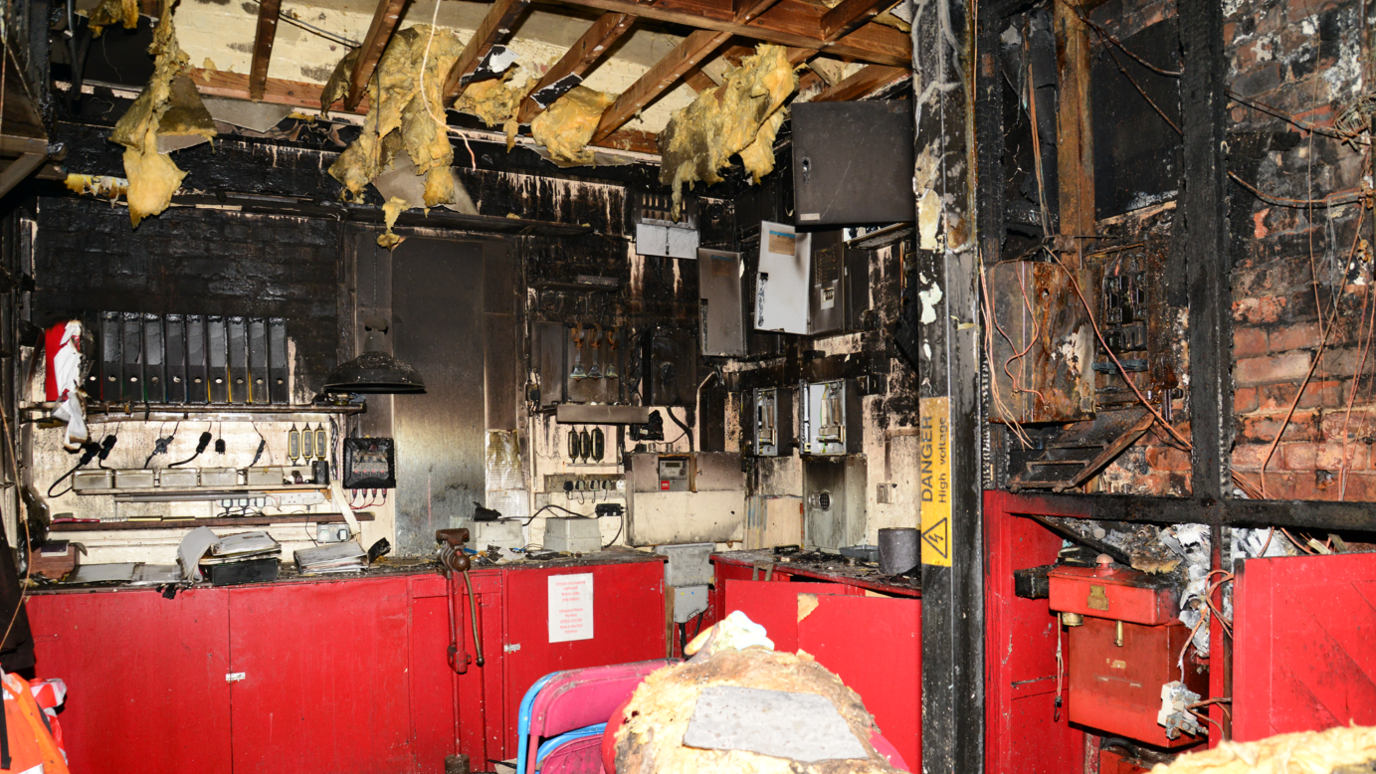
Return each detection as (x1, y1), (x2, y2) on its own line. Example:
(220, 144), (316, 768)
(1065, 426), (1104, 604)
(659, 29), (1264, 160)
(791, 101), (916, 226)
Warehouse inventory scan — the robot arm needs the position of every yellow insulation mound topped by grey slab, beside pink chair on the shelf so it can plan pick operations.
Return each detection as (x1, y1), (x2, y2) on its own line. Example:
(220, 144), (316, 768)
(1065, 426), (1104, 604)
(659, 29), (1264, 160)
(616, 647), (897, 774)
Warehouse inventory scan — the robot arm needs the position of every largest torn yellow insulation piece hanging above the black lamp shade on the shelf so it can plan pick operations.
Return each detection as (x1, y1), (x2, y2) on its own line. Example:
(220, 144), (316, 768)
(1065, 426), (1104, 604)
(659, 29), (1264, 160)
(322, 25), (464, 247)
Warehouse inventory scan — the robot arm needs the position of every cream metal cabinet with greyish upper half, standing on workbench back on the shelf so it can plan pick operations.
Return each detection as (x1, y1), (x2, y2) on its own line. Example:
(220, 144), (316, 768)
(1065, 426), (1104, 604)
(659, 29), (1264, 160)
(625, 452), (746, 545)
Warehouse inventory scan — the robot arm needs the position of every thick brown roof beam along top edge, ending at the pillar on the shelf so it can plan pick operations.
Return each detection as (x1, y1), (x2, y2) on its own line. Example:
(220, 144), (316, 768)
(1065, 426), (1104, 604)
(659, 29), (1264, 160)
(525, 0), (912, 67)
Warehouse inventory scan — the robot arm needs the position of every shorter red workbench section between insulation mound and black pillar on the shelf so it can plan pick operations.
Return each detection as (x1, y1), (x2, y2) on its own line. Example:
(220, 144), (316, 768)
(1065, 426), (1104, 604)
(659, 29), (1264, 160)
(703, 550), (922, 771)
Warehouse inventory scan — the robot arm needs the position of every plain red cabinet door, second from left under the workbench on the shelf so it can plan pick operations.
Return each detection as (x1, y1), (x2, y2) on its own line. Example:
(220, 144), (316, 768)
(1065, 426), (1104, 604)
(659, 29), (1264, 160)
(228, 577), (414, 774)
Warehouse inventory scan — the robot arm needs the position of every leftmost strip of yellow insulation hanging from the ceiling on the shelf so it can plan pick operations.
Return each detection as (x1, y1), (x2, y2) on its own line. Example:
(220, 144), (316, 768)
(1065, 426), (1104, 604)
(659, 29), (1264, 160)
(110, 0), (215, 227)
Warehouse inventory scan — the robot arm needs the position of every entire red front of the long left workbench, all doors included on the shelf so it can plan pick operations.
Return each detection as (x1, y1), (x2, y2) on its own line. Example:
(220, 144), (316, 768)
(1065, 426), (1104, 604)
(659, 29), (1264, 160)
(28, 550), (666, 774)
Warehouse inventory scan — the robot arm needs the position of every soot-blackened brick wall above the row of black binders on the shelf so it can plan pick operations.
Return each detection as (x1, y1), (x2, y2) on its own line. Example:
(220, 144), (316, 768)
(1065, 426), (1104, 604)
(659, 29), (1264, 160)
(33, 198), (341, 397)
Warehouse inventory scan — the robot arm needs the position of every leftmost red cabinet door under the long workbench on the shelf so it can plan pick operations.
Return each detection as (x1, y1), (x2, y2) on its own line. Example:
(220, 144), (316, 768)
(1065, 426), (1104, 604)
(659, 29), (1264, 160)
(28, 588), (231, 774)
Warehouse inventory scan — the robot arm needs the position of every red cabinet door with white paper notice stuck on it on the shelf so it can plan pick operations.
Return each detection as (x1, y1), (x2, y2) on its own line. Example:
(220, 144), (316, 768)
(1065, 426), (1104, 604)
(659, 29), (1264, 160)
(498, 562), (665, 768)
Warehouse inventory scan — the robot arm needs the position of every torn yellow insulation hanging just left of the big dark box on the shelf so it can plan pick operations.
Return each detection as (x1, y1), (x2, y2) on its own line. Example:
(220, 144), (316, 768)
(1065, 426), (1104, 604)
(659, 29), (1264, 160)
(659, 44), (798, 217)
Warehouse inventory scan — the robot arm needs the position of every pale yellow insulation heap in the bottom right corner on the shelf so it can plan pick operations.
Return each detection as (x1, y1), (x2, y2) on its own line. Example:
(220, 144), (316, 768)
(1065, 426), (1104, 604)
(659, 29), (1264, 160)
(1152, 726), (1376, 774)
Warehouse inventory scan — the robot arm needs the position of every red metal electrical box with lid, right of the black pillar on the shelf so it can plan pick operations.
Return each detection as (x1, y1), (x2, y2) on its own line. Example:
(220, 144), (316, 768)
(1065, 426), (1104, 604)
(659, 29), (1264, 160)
(1047, 566), (1208, 748)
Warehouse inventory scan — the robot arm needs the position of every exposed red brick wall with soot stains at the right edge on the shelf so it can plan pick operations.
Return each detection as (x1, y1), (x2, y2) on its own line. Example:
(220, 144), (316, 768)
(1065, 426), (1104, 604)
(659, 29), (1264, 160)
(1225, 0), (1376, 500)
